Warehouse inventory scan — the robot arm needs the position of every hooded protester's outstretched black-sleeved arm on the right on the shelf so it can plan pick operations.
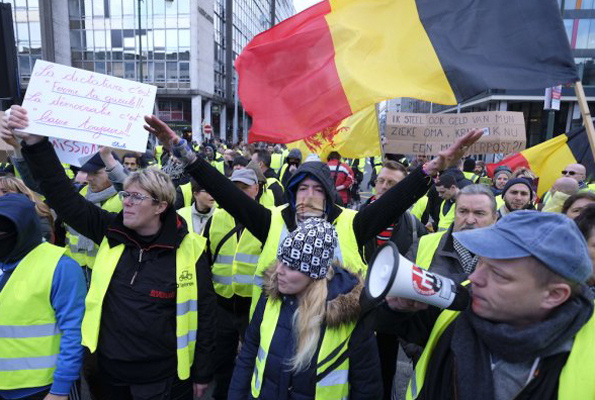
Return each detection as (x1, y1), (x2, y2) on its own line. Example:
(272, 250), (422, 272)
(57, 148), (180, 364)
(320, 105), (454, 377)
(353, 129), (483, 247)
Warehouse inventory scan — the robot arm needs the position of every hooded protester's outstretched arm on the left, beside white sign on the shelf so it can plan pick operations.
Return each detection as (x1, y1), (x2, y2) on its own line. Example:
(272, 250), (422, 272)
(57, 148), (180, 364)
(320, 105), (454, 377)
(145, 116), (271, 243)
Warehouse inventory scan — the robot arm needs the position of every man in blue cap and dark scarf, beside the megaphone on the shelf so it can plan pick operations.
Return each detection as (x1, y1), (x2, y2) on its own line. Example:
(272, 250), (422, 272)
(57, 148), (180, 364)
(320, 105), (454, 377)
(388, 210), (595, 400)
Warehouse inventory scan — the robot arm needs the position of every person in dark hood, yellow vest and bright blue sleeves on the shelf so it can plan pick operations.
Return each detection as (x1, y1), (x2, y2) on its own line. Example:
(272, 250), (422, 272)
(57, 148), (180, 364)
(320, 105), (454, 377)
(0, 194), (86, 400)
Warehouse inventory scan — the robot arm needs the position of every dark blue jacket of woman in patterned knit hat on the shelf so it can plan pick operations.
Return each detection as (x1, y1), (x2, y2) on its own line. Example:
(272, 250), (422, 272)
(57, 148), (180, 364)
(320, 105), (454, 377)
(228, 267), (382, 400)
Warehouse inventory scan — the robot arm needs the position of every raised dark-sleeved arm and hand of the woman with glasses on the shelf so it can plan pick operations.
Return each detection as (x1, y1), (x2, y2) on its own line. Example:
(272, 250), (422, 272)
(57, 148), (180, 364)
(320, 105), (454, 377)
(0, 106), (116, 244)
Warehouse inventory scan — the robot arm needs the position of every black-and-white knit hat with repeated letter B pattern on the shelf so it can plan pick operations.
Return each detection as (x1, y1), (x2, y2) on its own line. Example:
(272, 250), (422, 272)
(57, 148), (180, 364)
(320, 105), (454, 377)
(277, 218), (338, 279)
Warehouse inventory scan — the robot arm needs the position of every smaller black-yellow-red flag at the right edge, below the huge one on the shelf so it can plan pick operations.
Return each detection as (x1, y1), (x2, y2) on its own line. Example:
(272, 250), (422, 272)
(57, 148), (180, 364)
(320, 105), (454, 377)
(486, 127), (595, 197)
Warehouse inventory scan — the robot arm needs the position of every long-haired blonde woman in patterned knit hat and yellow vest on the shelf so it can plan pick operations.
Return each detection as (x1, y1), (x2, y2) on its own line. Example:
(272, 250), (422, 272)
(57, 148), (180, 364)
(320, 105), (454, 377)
(228, 218), (382, 400)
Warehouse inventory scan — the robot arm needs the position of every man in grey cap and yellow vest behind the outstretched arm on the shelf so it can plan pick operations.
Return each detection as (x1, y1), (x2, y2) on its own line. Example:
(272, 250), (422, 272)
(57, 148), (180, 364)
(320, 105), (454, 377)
(204, 168), (262, 400)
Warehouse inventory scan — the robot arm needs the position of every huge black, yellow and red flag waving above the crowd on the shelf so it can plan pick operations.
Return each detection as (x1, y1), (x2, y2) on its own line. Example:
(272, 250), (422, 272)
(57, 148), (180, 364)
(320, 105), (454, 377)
(235, 0), (578, 143)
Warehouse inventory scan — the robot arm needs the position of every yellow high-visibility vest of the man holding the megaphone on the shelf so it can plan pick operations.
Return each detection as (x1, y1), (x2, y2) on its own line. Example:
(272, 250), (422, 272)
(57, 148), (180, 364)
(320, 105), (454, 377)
(406, 302), (595, 400)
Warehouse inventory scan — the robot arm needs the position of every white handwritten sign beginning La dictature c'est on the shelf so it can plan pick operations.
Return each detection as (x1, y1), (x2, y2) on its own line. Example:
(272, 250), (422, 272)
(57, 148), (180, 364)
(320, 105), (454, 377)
(23, 60), (157, 152)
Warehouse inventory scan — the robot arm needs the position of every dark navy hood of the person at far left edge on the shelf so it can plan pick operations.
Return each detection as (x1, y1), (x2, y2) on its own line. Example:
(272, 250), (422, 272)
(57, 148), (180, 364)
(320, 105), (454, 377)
(0, 193), (42, 263)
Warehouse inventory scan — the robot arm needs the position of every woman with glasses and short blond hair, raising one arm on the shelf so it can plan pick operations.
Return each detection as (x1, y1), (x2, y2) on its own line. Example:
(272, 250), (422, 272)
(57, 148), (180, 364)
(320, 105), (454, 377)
(0, 106), (216, 400)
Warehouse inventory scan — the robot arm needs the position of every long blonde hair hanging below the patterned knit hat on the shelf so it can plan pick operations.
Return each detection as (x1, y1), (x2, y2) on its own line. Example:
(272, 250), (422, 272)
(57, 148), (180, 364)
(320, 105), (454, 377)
(265, 261), (335, 372)
